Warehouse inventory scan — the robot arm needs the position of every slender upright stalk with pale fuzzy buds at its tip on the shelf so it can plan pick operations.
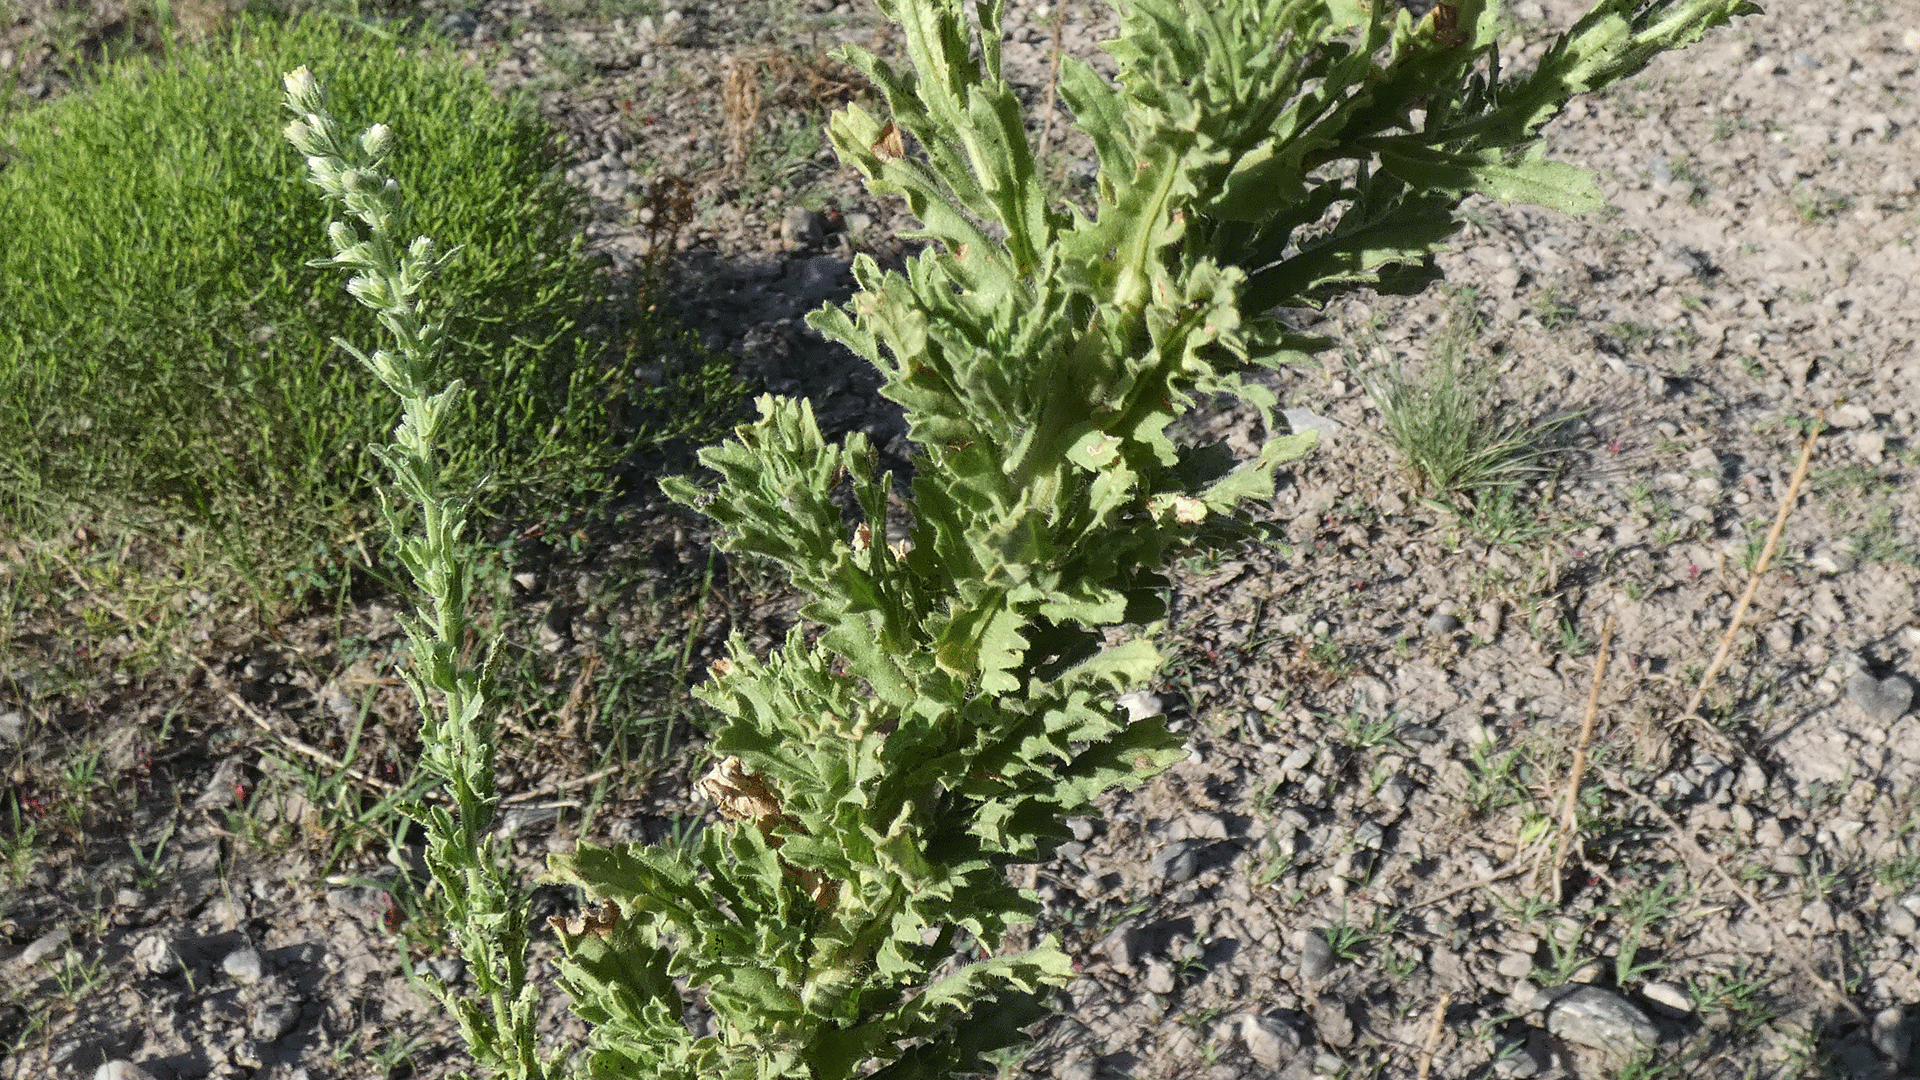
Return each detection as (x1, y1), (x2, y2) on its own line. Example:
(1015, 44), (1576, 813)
(286, 67), (557, 1080)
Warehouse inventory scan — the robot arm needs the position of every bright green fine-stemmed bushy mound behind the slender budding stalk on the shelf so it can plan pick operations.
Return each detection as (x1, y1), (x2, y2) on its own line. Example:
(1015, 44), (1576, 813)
(0, 15), (737, 605)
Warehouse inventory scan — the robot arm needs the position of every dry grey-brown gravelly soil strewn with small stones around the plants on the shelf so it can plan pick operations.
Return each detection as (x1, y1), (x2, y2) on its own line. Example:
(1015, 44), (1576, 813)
(0, 0), (1920, 1080)
